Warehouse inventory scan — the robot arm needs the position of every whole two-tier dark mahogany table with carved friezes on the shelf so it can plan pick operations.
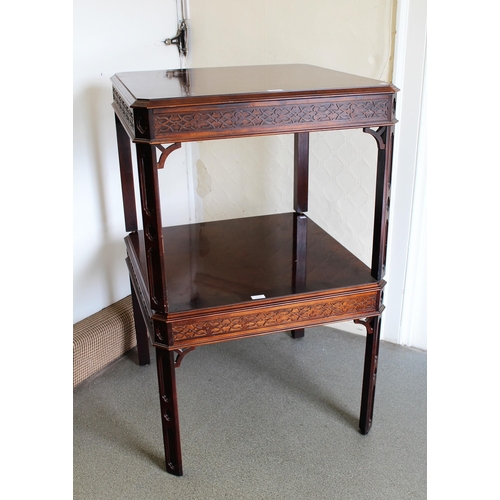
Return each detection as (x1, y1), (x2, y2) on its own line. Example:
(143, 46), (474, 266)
(111, 65), (397, 476)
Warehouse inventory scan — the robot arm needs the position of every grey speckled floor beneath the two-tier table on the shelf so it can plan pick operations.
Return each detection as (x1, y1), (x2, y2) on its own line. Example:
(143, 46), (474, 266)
(73, 327), (427, 500)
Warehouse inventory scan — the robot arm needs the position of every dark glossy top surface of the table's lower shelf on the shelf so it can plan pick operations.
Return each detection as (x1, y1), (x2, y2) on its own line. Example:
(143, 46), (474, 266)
(127, 213), (376, 313)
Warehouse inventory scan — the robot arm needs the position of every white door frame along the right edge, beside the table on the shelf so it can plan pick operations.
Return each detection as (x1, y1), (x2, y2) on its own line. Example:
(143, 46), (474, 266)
(382, 0), (427, 345)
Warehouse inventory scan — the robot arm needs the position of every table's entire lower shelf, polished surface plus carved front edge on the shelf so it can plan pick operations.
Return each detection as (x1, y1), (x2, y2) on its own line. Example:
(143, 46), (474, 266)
(125, 213), (385, 348)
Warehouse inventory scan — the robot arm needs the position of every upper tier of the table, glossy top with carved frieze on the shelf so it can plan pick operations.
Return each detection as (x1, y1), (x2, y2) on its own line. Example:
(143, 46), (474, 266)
(111, 64), (397, 144)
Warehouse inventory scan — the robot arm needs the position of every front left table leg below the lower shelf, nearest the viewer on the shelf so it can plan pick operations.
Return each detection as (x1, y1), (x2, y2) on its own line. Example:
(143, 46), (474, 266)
(156, 348), (182, 476)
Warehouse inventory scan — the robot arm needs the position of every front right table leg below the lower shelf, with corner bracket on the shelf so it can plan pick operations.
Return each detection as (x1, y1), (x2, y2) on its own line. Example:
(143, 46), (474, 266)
(356, 316), (381, 434)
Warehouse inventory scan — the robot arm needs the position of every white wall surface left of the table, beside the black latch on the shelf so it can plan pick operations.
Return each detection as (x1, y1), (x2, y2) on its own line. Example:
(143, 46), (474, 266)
(73, 0), (189, 322)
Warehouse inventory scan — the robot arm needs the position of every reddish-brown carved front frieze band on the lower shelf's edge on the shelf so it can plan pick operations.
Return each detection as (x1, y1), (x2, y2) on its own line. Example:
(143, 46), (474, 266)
(172, 293), (377, 341)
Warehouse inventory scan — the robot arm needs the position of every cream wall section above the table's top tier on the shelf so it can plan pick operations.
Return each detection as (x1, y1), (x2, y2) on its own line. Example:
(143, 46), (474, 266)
(189, 0), (396, 80)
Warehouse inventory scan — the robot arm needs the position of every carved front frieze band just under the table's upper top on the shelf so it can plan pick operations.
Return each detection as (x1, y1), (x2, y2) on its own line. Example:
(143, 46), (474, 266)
(154, 99), (391, 137)
